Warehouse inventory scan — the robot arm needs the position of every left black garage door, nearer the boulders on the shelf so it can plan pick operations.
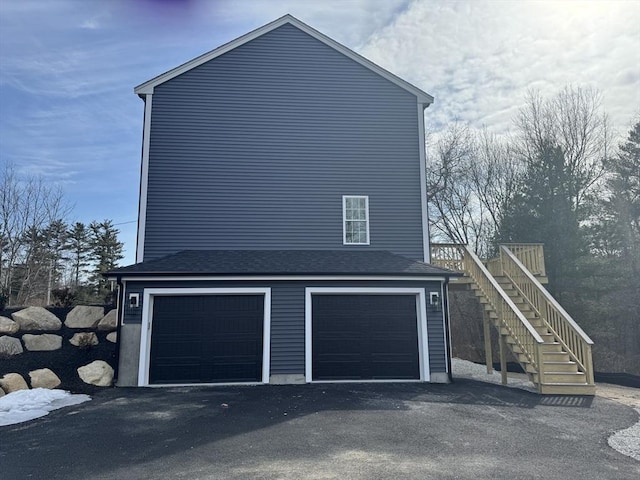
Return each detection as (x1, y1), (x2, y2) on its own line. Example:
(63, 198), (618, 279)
(149, 295), (264, 384)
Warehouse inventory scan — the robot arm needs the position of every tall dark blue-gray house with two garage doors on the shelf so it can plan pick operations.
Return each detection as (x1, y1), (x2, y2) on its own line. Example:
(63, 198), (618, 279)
(109, 15), (458, 386)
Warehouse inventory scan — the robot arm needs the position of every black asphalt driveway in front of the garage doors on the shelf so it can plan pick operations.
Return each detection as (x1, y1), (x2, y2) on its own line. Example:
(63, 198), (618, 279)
(0, 379), (640, 480)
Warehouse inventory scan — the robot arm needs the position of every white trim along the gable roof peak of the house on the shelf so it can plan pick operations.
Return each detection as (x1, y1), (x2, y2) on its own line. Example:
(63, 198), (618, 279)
(134, 14), (433, 107)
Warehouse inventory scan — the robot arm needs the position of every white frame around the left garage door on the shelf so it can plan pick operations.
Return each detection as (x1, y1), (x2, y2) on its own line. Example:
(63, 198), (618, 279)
(138, 288), (271, 387)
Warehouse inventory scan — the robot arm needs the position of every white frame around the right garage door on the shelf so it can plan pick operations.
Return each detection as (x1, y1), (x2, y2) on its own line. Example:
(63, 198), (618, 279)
(304, 287), (430, 383)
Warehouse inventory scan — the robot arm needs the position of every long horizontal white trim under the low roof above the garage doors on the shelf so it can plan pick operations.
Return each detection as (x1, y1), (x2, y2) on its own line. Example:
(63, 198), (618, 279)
(114, 275), (445, 282)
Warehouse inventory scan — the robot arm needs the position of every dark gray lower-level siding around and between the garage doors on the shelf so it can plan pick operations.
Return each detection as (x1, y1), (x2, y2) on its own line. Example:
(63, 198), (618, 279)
(124, 281), (446, 375)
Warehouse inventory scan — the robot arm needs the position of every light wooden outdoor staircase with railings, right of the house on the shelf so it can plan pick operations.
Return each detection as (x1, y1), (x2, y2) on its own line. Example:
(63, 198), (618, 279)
(432, 244), (595, 395)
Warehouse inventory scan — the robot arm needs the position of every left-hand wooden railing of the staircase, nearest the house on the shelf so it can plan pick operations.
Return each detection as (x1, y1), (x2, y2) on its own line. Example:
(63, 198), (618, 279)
(431, 244), (544, 384)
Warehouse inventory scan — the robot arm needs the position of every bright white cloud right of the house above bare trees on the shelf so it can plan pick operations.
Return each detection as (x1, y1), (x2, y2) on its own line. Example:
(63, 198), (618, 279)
(362, 1), (640, 133)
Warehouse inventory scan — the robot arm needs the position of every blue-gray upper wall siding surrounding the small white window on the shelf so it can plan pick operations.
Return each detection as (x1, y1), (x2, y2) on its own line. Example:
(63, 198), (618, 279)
(144, 25), (423, 260)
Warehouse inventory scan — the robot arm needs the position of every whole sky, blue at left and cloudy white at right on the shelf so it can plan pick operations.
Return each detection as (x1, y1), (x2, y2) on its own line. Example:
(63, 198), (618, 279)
(0, 0), (640, 265)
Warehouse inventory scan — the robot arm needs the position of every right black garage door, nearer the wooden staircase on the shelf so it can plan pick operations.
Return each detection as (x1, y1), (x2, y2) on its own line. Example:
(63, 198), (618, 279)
(311, 295), (420, 380)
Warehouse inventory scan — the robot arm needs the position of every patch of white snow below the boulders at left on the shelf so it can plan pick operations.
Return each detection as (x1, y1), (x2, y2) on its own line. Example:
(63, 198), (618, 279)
(0, 388), (91, 426)
